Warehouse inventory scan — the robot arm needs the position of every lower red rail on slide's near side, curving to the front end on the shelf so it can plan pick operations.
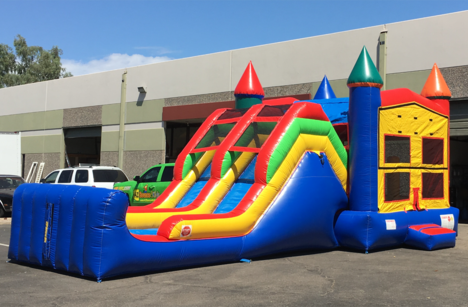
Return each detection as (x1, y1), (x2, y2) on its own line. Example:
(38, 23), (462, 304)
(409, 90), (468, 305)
(158, 183), (265, 238)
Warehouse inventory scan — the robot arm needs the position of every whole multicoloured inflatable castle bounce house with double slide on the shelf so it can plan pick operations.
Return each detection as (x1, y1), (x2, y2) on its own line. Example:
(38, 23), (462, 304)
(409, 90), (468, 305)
(8, 48), (458, 281)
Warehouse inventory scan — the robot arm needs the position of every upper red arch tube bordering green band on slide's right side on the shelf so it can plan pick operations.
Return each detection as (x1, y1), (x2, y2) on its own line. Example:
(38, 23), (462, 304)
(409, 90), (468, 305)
(255, 102), (329, 184)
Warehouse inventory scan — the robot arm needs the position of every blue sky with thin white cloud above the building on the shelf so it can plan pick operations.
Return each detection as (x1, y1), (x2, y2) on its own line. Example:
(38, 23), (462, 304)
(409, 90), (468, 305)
(0, 0), (468, 76)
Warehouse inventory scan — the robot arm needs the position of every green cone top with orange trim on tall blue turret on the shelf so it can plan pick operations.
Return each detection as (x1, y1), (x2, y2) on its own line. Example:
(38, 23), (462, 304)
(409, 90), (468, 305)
(347, 46), (383, 88)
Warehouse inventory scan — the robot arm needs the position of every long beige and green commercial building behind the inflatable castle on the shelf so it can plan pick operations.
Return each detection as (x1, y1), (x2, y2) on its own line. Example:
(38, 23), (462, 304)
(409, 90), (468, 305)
(0, 11), (468, 218)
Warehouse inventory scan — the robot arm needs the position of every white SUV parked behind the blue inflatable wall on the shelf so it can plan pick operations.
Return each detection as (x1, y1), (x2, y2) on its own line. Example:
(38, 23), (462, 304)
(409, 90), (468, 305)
(41, 166), (128, 189)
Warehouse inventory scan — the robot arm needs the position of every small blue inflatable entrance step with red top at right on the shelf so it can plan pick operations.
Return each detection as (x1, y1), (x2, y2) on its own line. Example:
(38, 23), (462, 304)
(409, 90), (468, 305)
(405, 224), (457, 250)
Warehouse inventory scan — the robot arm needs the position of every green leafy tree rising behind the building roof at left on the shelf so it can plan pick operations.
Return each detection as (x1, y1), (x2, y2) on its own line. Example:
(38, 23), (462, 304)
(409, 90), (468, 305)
(0, 35), (73, 88)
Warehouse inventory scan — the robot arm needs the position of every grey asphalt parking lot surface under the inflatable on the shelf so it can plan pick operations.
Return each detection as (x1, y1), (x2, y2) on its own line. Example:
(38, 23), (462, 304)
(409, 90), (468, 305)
(0, 218), (468, 307)
